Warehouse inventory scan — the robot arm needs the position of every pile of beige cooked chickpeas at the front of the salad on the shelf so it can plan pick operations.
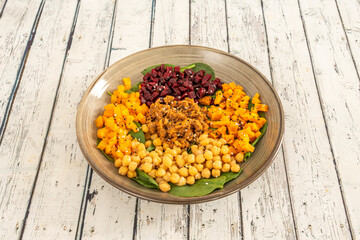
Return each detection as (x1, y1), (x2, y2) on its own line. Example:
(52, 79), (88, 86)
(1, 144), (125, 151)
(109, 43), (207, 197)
(115, 132), (244, 192)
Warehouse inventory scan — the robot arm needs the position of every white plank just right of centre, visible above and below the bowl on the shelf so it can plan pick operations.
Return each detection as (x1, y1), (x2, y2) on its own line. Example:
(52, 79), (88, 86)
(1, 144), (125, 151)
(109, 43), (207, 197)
(189, 0), (242, 239)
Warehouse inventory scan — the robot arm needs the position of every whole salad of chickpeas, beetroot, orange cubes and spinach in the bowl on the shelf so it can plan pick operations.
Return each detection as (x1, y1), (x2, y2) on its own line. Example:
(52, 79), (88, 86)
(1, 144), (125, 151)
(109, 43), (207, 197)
(95, 63), (268, 197)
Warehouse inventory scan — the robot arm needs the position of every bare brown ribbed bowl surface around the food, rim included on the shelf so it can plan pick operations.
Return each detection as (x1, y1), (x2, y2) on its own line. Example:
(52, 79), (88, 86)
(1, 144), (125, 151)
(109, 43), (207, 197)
(76, 46), (284, 204)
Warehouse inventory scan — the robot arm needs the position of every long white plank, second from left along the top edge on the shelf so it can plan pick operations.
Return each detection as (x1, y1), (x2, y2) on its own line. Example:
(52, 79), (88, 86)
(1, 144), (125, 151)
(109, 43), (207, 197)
(0, 0), (76, 239)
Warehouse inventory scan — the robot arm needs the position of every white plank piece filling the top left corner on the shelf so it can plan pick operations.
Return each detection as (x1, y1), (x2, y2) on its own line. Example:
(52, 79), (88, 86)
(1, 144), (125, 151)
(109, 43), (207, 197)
(0, 0), (41, 123)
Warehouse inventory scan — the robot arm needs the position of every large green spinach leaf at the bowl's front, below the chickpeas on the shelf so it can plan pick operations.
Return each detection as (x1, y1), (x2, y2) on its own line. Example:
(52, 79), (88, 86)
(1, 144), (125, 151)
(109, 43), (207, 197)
(169, 176), (226, 197)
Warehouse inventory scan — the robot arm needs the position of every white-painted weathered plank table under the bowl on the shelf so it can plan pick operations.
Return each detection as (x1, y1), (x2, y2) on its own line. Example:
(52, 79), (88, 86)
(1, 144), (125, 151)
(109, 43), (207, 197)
(0, 0), (360, 240)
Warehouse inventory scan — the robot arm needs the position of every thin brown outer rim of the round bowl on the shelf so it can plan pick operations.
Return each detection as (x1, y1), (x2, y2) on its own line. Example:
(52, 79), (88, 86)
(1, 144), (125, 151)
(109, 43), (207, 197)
(76, 44), (285, 204)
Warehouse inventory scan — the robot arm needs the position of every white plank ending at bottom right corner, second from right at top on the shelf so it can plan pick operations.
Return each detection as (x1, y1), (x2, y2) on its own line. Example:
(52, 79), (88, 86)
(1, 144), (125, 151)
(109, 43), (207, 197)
(300, 0), (360, 238)
